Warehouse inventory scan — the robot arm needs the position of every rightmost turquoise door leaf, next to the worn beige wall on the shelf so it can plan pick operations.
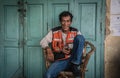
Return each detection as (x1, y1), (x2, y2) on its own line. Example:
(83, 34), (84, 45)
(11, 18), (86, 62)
(74, 0), (103, 78)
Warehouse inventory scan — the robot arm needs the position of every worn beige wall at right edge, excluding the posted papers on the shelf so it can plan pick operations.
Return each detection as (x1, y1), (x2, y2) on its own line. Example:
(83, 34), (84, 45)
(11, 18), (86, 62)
(105, 0), (120, 78)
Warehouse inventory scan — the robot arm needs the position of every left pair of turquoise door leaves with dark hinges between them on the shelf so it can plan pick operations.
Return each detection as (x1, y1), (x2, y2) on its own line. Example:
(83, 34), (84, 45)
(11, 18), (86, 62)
(0, 0), (47, 78)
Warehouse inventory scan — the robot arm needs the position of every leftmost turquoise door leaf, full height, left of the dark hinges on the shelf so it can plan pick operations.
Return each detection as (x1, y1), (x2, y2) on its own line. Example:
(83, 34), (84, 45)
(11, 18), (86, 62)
(0, 0), (23, 78)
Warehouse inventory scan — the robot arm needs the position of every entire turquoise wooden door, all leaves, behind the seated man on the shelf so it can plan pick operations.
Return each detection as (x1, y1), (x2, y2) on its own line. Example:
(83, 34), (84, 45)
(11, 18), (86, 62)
(0, 0), (104, 78)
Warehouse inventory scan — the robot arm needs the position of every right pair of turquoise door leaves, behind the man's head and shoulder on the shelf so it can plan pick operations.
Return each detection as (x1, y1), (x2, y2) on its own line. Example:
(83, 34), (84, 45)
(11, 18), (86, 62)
(48, 0), (104, 78)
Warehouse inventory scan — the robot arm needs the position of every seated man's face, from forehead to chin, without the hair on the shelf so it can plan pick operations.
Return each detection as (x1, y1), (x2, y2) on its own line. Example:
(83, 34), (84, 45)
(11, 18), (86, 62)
(61, 16), (72, 31)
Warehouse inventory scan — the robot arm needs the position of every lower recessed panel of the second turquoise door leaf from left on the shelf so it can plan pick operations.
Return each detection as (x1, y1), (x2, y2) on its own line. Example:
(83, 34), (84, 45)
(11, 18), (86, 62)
(24, 46), (43, 78)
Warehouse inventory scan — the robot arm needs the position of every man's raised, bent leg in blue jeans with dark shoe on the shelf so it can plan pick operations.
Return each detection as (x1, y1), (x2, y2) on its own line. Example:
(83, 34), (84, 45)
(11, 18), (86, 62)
(71, 35), (85, 76)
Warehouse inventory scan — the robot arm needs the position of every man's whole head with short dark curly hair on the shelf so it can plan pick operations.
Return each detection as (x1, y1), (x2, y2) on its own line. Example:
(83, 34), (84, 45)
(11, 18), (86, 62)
(59, 11), (73, 32)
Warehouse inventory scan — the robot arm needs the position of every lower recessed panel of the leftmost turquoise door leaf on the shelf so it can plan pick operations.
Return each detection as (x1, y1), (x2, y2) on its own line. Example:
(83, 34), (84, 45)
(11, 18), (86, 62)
(4, 46), (20, 78)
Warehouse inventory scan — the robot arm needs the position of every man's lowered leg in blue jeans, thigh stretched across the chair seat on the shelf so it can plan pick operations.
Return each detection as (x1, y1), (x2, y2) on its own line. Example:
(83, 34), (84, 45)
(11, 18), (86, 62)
(44, 59), (69, 78)
